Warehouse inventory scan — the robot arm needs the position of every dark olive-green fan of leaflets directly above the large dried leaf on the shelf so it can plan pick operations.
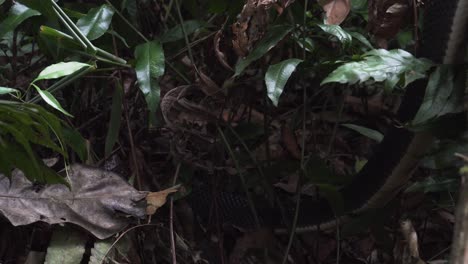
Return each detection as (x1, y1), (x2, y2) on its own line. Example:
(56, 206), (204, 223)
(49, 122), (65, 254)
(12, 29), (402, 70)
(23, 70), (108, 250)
(0, 101), (83, 183)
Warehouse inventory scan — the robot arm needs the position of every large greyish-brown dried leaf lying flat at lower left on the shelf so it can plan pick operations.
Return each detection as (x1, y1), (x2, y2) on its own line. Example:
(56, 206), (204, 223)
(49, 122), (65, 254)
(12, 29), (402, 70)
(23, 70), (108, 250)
(0, 164), (146, 239)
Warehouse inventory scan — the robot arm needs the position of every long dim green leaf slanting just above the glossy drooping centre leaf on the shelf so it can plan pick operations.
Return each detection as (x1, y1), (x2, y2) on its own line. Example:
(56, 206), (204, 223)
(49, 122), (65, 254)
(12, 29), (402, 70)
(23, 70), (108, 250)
(234, 25), (292, 76)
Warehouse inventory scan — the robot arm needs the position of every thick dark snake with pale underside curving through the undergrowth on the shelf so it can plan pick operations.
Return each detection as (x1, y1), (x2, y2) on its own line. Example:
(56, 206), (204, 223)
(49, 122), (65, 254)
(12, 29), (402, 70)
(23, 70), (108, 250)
(187, 0), (468, 233)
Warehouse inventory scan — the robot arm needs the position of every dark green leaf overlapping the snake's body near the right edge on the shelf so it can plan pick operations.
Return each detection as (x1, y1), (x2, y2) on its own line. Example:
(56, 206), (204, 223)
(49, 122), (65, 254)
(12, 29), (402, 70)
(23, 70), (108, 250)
(411, 65), (466, 125)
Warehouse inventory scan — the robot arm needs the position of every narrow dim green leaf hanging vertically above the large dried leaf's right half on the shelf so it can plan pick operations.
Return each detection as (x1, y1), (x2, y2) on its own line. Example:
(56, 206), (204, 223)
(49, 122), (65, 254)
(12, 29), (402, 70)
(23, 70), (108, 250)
(104, 83), (123, 157)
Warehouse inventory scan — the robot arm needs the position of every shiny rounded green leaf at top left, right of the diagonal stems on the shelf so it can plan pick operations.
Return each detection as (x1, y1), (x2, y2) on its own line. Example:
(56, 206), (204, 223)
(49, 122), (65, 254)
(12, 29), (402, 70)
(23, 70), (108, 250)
(76, 5), (114, 40)
